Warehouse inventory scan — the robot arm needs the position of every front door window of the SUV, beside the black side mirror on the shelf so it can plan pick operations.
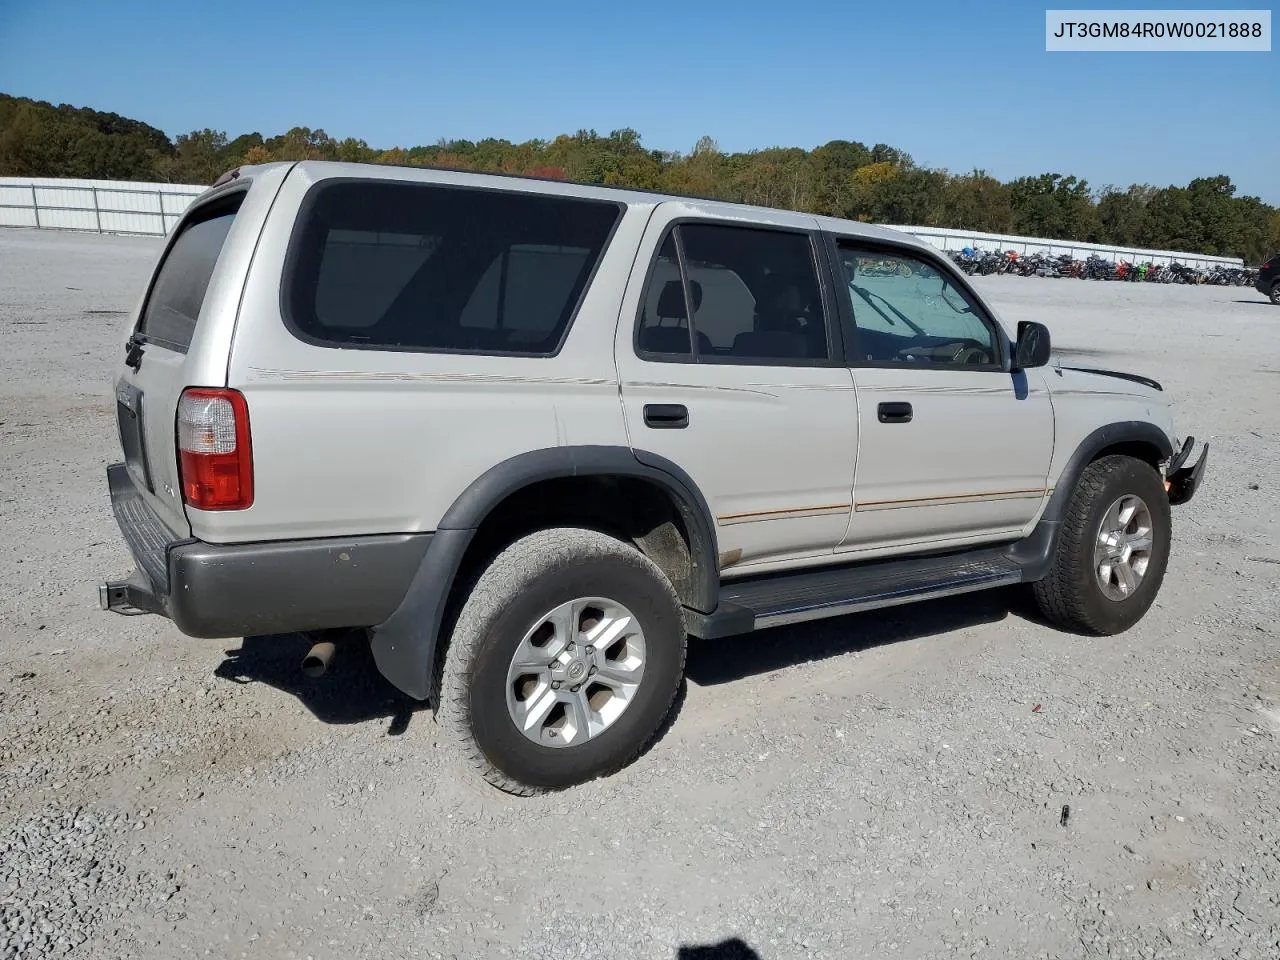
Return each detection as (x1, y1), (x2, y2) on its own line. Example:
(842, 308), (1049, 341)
(840, 243), (1000, 366)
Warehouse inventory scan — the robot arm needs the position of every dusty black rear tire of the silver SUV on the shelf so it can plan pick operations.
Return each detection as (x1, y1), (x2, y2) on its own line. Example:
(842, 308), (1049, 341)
(436, 527), (685, 796)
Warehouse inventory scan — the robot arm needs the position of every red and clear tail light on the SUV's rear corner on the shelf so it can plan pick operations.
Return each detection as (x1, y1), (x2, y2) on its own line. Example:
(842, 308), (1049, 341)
(178, 388), (253, 509)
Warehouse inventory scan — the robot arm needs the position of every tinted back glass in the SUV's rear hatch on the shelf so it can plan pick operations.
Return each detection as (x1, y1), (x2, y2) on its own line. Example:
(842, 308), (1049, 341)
(138, 191), (244, 352)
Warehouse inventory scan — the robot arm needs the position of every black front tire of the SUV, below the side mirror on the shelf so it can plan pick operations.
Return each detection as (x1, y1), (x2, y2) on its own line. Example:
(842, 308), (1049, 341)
(1033, 456), (1172, 636)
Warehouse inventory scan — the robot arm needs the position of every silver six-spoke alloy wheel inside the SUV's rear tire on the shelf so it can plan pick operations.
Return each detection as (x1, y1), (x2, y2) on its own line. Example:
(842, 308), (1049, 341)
(507, 596), (645, 748)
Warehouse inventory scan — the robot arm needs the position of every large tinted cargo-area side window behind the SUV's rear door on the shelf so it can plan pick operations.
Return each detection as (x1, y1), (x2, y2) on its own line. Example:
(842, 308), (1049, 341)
(284, 180), (622, 355)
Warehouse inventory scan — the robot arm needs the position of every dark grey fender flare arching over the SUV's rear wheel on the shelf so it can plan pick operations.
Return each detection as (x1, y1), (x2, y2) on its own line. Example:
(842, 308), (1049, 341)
(371, 445), (719, 700)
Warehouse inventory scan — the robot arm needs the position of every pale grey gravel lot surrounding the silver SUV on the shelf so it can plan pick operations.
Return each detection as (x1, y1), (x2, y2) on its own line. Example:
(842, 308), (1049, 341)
(0, 230), (1280, 960)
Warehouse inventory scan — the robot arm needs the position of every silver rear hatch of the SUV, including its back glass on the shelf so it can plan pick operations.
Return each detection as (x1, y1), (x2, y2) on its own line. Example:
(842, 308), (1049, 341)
(115, 172), (275, 539)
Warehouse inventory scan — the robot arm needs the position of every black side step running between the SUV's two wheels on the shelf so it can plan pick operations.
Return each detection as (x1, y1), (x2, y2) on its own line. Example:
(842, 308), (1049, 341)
(686, 548), (1023, 639)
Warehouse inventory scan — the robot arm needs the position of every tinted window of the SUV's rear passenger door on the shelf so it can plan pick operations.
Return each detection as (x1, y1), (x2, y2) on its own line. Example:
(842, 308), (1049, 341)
(636, 223), (831, 364)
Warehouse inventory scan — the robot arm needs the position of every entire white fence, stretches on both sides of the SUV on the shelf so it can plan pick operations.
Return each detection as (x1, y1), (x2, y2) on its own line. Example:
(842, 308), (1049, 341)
(0, 177), (1243, 268)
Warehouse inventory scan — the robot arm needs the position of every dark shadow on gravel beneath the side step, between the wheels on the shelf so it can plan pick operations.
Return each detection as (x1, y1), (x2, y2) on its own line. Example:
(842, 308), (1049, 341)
(685, 588), (1013, 686)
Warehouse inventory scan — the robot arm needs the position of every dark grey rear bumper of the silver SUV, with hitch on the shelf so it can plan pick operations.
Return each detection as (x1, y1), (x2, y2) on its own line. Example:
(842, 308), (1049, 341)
(99, 463), (431, 637)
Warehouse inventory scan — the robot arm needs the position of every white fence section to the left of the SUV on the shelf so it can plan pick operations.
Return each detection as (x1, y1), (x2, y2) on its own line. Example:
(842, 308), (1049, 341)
(0, 177), (206, 237)
